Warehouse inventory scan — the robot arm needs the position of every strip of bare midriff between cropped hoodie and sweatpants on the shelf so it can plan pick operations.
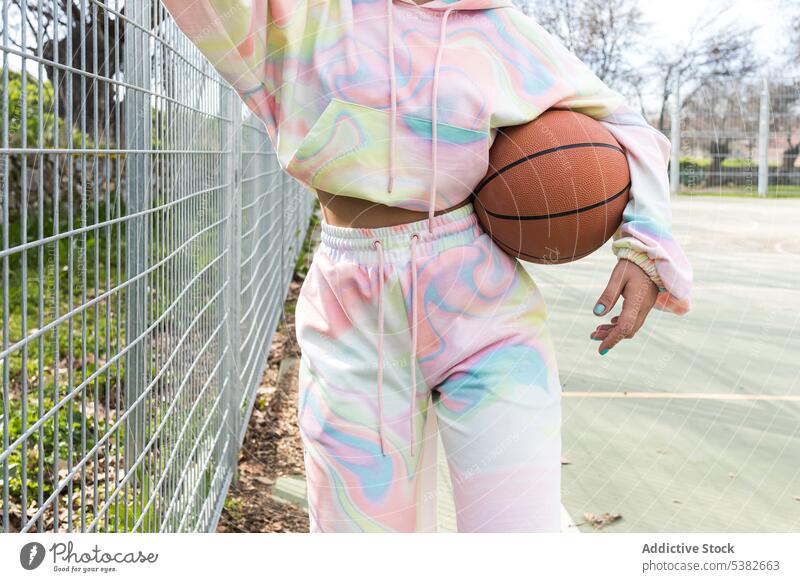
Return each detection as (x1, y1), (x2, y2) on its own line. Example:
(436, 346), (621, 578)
(317, 190), (470, 228)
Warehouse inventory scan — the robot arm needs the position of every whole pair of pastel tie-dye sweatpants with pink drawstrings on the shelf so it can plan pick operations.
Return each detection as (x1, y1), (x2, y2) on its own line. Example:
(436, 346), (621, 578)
(296, 204), (561, 532)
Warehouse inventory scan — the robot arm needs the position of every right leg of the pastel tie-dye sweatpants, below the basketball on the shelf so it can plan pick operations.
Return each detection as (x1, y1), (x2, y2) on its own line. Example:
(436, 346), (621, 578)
(410, 224), (561, 532)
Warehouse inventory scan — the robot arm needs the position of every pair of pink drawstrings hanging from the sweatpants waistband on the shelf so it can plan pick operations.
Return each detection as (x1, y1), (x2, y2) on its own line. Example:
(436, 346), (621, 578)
(372, 234), (419, 457)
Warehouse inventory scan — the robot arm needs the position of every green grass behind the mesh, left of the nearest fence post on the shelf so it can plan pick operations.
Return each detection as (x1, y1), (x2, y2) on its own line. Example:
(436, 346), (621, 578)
(0, 198), (130, 525)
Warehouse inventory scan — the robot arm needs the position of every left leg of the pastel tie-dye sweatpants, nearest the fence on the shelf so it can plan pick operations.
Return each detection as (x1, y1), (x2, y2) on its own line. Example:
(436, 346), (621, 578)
(296, 237), (430, 532)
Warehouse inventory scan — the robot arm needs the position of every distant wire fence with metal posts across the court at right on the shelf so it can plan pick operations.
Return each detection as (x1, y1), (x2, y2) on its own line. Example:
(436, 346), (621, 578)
(664, 76), (800, 196)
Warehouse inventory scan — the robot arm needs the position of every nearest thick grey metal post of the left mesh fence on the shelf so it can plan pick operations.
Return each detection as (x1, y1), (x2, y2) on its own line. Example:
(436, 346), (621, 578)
(124, 0), (152, 484)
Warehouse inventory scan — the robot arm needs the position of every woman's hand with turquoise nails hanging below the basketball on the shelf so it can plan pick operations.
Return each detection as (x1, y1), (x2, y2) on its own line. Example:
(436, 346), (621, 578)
(589, 259), (658, 356)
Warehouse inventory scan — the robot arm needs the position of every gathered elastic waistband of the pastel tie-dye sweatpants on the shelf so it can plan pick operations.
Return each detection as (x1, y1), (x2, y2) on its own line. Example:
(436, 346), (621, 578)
(320, 202), (483, 265)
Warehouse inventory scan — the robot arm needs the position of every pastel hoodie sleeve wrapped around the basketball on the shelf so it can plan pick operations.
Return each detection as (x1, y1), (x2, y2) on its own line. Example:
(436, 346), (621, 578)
(493, 8), (692, 315)
